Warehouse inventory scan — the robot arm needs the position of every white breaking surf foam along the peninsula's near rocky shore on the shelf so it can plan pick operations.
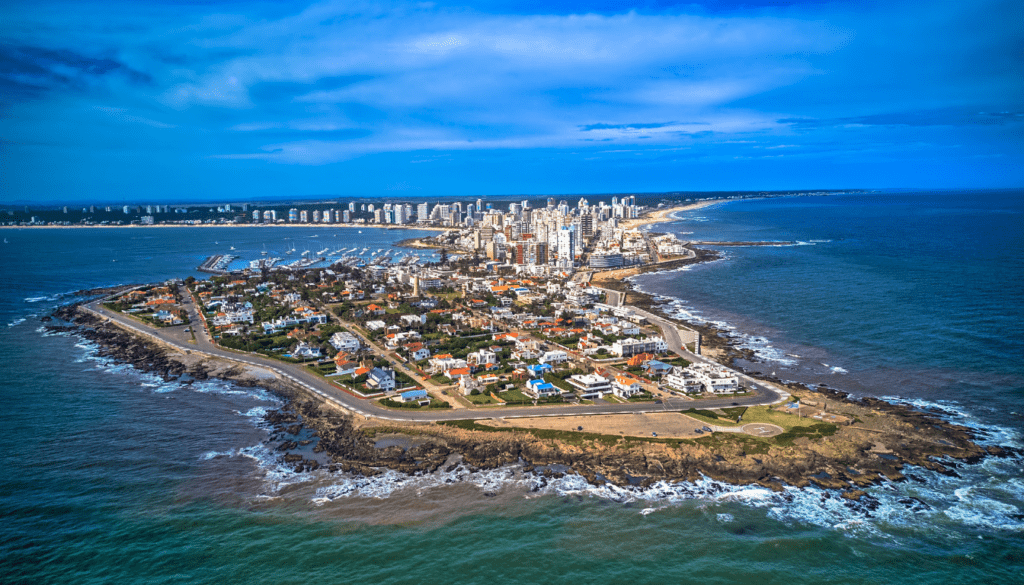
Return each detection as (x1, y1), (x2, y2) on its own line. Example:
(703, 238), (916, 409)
(195, 411), (1024, 537)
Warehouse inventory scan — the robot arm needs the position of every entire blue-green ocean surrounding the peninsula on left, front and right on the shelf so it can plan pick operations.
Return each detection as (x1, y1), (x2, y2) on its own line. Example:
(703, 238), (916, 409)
(0, 197), (1024, 584)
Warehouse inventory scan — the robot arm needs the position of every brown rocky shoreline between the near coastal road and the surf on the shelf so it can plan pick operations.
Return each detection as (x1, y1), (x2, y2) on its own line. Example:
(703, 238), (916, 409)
(48, 293), (1015, 499)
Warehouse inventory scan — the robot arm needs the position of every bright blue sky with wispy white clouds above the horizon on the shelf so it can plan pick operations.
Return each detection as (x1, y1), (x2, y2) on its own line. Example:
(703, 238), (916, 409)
(0, 0), (1024, 203)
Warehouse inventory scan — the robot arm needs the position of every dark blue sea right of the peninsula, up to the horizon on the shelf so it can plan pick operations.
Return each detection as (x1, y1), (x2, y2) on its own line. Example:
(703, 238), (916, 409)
(638, 191), (1024, 428)
